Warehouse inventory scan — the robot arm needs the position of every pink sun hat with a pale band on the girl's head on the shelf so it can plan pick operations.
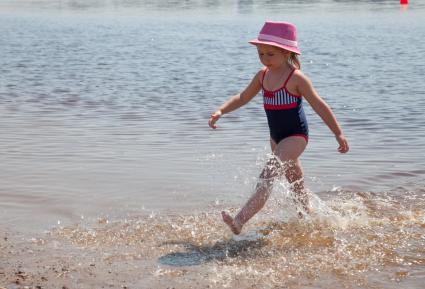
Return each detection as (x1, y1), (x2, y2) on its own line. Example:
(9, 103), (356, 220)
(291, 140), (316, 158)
(249, 21), (301, 54)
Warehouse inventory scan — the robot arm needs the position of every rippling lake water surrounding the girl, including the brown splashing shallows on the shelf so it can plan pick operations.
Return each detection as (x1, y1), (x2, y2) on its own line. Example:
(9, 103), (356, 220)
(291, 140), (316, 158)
(0, 1), (425, 288)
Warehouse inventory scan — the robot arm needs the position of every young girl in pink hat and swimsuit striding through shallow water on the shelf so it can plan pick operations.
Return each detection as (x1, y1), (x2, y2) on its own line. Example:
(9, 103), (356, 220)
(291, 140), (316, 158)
(208, 22), (348, 234)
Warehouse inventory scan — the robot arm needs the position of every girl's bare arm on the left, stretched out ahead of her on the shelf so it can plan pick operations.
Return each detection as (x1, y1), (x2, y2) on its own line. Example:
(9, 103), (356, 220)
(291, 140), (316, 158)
(208, 70), (263, 129)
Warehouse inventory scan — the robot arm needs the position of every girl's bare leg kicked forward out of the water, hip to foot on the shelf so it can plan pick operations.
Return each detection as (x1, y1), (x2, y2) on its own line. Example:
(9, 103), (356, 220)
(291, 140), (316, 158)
(222, 136), (307, 234)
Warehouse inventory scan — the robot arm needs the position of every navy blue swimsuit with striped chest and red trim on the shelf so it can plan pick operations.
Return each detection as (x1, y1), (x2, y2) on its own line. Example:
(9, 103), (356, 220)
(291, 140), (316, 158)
(261, 69), (308, 144)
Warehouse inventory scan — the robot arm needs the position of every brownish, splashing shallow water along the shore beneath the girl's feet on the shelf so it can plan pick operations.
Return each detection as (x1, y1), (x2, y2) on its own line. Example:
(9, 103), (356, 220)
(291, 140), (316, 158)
(1, 190), (425, 288)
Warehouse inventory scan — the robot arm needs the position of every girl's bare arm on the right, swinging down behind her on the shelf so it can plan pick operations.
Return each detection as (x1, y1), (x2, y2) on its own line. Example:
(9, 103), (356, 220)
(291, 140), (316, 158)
(297, 72), (349, 153)
